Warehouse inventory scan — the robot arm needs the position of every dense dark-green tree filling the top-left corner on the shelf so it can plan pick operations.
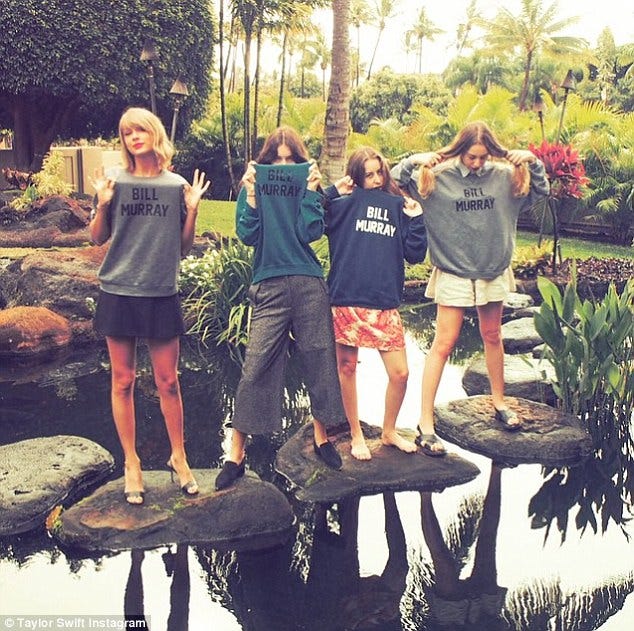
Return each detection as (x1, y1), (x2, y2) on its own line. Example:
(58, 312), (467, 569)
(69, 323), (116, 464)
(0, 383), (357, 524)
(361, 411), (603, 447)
(0, 0), (215, 170)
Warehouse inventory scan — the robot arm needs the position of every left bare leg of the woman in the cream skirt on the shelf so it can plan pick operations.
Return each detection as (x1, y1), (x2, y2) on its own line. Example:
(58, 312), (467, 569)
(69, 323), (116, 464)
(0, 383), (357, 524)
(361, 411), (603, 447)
(419, 305), (464, 450)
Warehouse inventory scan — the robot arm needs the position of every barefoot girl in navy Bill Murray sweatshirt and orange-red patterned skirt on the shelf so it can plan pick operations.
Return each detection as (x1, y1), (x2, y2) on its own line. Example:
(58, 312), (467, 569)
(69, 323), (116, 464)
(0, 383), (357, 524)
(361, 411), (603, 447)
(326, 147), (427, 460)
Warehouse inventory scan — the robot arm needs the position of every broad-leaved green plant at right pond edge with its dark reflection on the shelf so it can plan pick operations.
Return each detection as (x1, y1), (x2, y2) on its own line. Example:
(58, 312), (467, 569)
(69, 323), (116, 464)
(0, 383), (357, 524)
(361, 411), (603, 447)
(529, 272), (634, 537)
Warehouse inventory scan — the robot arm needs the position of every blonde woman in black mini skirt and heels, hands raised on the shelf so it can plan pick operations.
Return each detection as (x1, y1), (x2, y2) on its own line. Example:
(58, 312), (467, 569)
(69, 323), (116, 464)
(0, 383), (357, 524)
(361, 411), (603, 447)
(90, 107), (210, 505)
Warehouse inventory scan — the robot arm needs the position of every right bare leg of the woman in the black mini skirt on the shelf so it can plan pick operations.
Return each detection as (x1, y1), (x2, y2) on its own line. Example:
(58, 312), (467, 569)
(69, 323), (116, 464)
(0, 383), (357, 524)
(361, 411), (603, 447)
(147, 337), (198, 495)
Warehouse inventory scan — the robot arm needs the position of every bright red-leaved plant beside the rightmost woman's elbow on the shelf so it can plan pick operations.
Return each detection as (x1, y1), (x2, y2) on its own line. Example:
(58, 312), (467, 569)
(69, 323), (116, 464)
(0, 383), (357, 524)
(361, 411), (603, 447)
(528, 140), (590, 199)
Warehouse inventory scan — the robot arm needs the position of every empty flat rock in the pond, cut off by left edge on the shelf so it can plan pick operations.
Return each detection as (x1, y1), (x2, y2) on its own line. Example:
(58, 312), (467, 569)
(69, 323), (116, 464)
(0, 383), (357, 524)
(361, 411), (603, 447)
(0, 436), (114, 535)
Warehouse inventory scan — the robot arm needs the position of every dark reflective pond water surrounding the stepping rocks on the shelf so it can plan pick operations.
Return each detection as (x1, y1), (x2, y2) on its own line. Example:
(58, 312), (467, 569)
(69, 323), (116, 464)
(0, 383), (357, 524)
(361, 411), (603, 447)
(0, 307), (634, 631)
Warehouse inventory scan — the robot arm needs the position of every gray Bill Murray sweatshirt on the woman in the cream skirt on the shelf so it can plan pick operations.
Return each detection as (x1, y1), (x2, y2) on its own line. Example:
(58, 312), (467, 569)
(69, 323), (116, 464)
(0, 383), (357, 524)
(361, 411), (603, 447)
(392, 158), (549, 280)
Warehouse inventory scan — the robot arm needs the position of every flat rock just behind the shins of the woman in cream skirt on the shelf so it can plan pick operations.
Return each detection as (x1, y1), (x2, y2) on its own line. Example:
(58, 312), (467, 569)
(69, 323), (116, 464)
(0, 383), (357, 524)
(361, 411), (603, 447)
(462, 353), (557, 404)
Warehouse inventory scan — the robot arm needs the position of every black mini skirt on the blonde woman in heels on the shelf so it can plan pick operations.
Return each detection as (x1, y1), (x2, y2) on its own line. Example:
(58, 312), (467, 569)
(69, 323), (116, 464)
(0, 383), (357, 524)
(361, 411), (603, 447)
(93, 290), (185, 339)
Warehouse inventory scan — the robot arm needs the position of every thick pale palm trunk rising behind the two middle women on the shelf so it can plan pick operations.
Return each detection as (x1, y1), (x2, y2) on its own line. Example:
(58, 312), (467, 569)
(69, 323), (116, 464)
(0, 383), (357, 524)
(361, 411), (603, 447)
(320, 0), (350, 182)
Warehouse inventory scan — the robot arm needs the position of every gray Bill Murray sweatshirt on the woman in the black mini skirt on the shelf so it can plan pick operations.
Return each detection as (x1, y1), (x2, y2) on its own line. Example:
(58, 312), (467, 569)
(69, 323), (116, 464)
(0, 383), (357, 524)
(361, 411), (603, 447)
(99, 169), (187, 297)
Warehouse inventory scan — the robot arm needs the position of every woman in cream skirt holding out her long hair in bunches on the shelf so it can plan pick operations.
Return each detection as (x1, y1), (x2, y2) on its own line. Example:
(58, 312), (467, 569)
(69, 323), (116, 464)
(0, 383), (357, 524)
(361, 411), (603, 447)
(393, 122), (549, 456)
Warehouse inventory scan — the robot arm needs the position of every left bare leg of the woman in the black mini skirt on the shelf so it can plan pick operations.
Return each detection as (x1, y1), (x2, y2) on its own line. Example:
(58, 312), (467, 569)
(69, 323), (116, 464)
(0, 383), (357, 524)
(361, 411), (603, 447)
(106, 337), (143, 504)
